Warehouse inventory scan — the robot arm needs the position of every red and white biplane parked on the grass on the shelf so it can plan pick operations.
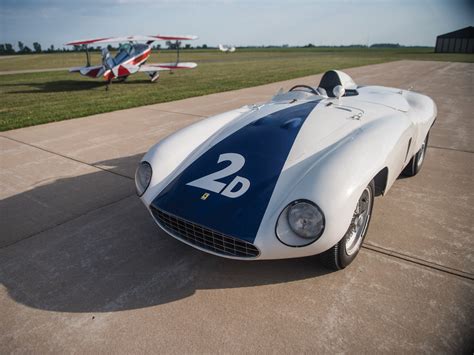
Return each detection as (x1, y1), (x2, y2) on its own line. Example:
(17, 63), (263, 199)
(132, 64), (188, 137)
(66, 35), (198, 90)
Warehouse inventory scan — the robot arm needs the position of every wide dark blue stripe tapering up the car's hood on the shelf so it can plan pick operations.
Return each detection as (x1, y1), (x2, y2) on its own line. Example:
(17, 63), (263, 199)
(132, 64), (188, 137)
(152, 101), (319, 243)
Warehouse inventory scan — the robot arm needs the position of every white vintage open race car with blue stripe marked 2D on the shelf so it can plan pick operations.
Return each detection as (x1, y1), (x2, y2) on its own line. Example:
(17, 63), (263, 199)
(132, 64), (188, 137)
(135, 70), (437, 269)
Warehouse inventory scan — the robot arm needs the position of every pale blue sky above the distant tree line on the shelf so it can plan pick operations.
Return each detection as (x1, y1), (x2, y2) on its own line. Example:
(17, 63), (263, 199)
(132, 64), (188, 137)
(0, 0), (474, 48)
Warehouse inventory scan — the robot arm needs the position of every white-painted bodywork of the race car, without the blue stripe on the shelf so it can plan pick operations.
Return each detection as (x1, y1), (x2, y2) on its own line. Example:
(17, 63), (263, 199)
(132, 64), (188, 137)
(137, 74), (437, 260)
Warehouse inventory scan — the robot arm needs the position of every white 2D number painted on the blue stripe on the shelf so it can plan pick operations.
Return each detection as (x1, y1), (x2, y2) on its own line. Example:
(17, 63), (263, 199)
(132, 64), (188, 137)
(186, 153), (250, 198)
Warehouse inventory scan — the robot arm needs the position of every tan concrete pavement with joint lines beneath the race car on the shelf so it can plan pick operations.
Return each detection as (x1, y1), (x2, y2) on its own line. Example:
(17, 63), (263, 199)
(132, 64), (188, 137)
(0, 61), (474, 353)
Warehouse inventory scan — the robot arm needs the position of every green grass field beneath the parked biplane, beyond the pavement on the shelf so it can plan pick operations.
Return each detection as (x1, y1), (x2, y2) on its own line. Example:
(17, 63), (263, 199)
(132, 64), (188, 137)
(0, 48), (474, 131)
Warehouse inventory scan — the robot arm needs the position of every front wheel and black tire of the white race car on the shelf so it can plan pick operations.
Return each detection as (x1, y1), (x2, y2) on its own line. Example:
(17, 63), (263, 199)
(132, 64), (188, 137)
(322, 180), (375, 270)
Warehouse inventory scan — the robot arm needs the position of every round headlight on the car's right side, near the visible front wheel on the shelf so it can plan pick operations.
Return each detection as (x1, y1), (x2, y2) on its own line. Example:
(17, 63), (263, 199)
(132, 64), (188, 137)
(276, 200), (325, 247)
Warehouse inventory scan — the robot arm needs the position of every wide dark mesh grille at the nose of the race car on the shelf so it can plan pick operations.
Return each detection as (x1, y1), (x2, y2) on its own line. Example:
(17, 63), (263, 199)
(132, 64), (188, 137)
(151, 206), (260, 258)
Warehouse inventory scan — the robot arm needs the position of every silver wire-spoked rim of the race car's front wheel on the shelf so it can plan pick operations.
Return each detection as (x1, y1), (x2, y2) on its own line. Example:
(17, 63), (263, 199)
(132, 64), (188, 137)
(345, 187), (372, 255)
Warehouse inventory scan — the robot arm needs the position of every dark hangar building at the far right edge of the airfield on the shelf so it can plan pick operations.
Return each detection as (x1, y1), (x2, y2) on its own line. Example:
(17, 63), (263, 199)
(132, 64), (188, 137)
(435, 26), (474, 53)
